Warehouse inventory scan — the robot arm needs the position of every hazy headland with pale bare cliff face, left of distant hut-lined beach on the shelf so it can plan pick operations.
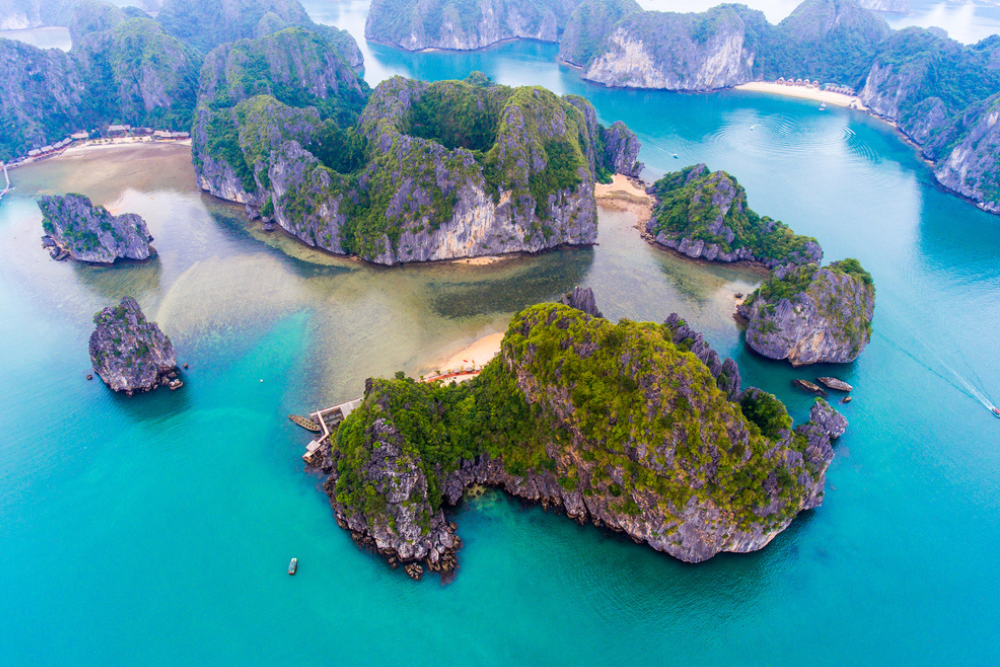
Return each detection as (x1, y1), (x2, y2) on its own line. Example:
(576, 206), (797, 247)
(584, 5), (766, 90)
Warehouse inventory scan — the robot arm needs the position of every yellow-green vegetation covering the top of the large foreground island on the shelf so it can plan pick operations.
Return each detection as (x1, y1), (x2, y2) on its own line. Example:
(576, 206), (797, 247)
(332, 304), (824, 530)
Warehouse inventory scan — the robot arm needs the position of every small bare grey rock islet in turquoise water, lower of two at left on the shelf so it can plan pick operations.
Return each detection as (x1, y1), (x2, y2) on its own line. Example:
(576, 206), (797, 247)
(90, 296), (182, 396)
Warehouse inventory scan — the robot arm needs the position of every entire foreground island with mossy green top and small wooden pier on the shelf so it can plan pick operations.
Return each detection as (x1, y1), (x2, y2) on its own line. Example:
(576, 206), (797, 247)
(314, 304), (844, 574)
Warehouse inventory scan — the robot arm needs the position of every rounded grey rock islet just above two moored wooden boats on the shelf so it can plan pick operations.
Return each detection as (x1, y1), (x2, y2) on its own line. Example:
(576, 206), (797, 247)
(739, 259), (875, 366)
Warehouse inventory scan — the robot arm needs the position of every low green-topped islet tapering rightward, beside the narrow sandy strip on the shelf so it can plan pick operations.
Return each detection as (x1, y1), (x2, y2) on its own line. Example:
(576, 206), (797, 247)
(646, 164), (823, 269)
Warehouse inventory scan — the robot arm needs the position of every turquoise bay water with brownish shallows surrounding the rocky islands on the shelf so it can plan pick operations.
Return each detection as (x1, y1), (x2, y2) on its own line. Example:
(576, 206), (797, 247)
(0, 3), (1000, 666)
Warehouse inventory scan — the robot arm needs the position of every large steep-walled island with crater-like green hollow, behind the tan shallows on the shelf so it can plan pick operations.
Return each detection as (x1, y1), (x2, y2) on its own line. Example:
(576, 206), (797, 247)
(202, 69), (641, 265)
